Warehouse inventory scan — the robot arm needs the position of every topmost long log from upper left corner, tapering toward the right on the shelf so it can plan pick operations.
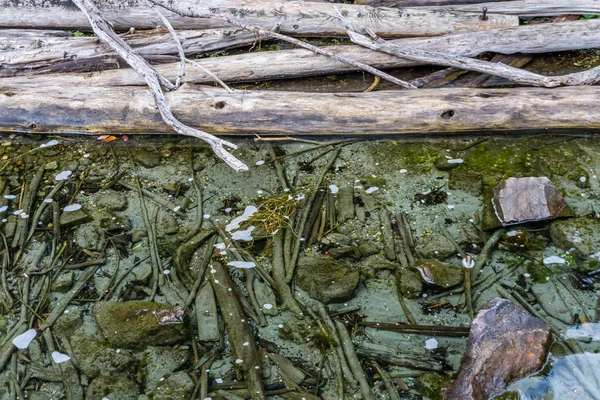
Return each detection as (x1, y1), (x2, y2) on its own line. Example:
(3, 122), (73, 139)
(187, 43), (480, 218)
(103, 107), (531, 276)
(0, 0), (519, 37)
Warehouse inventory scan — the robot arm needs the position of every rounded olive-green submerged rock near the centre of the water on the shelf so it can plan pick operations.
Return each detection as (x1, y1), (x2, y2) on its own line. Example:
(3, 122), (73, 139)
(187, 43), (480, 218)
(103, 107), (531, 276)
(296, 255), (360, 304)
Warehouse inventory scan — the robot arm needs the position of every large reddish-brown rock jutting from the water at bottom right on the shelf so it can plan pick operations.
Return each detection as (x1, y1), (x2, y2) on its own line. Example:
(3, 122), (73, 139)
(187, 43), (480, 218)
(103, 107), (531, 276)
(446, 298), (552, 400)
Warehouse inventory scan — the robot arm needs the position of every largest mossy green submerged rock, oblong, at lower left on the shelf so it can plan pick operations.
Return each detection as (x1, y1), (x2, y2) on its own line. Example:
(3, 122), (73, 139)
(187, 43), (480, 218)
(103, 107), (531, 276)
(92, 301), (187, 348)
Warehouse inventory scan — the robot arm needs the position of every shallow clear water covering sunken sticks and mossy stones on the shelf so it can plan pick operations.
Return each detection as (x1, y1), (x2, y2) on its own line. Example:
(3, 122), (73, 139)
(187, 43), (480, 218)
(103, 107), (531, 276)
(0, 136), (600, 399)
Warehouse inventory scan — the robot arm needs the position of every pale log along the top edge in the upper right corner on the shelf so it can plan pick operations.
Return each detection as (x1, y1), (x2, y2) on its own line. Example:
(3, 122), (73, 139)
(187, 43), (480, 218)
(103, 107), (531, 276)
(354, 0), (600, 17)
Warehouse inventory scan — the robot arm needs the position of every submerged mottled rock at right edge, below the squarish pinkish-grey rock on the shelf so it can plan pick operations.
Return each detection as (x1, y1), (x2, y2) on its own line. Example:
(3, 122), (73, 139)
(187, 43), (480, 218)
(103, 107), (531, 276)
(550, 217), (600, 258)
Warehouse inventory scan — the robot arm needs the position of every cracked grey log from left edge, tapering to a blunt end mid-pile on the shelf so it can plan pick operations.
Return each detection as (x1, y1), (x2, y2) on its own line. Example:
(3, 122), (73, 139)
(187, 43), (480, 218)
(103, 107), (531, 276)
(0, 28), (261, 77)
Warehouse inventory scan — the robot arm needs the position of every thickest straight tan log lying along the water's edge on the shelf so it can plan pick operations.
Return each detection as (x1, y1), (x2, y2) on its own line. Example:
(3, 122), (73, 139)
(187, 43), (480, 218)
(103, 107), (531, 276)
(0, 85), (600, 135)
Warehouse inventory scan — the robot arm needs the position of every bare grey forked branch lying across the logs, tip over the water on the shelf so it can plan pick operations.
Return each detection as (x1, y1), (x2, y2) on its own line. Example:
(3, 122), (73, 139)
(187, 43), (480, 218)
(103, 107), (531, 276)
(73, 0), (248, 171)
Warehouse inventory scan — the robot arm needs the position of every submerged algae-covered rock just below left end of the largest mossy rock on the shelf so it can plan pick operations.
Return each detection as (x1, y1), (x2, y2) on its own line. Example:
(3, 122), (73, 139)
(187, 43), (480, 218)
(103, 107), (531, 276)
(71, 335), (138, 378)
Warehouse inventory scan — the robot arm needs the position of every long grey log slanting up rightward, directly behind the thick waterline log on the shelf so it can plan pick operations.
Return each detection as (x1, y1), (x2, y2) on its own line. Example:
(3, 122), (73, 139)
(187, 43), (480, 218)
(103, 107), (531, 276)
(0, 20), (600, 87)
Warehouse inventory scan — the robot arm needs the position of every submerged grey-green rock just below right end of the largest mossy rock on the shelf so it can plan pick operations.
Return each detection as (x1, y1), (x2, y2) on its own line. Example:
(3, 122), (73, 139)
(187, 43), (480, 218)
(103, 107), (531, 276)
(139, 346), (191, 393)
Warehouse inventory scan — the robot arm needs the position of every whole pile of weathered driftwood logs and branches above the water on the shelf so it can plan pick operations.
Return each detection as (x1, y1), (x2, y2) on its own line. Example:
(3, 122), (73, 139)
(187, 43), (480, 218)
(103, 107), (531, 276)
(0, 0), (600, 170)
